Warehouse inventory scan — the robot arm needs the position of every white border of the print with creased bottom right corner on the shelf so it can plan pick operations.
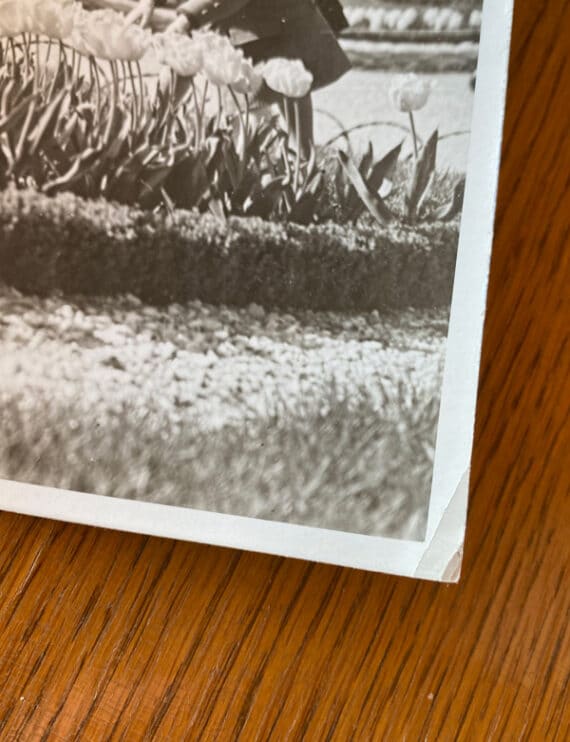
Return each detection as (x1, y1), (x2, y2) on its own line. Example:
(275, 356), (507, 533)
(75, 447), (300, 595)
(0, 0), (513, 582)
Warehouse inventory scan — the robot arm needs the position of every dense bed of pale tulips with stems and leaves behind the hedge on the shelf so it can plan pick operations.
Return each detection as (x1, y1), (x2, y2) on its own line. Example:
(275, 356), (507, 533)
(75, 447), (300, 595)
(0, 5), (321, 221)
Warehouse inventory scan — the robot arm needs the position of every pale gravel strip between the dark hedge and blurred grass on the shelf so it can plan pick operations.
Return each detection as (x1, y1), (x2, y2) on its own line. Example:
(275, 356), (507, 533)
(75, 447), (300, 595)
(0, 288), (447, 429)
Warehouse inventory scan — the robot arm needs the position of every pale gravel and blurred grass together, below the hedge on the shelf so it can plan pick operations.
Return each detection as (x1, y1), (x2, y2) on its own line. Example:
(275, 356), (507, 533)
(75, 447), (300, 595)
(0, 290), (447, 539)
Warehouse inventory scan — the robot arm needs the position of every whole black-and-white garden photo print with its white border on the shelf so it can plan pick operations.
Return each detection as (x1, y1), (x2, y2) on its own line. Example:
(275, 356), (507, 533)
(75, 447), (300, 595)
(0, 0), (511, 580)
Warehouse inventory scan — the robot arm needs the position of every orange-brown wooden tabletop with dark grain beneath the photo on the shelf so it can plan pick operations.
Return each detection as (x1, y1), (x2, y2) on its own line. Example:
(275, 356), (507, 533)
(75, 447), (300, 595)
(0, 0), (570, 742)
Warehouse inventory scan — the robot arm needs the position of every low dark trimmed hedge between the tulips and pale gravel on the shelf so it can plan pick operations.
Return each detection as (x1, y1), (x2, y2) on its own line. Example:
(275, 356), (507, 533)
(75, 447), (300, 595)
(0, 189), (459, 311)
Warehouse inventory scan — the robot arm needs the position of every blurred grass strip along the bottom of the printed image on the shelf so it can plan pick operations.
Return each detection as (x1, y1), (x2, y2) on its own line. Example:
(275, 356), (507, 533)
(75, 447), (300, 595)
(0, 381), (439, 540)
